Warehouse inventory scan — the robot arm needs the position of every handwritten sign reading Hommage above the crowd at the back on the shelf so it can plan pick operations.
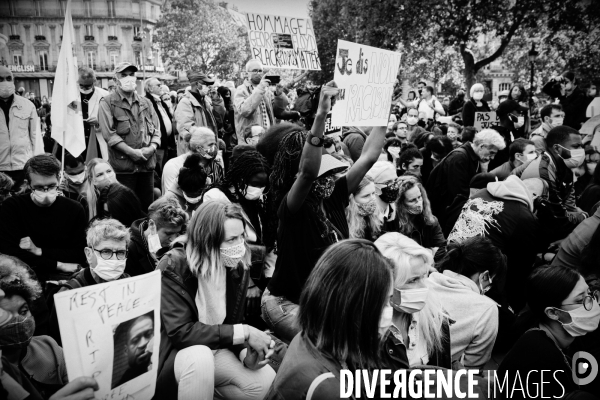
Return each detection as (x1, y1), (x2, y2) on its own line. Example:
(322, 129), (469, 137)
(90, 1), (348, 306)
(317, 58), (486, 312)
(246, 13), (321, 71)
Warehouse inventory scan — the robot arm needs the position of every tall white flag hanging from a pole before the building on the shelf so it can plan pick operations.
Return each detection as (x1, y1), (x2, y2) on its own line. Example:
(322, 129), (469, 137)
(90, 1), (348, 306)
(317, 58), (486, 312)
(51, 0), (85, 157)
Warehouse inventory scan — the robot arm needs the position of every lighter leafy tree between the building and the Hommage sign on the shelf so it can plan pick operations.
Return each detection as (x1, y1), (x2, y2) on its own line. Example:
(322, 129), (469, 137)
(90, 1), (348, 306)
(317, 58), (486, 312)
(154, 0), (248, 78)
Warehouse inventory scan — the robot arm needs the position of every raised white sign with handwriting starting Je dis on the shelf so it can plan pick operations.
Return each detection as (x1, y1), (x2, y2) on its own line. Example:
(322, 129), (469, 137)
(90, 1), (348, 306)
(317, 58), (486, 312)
(332, 40), (400, 126)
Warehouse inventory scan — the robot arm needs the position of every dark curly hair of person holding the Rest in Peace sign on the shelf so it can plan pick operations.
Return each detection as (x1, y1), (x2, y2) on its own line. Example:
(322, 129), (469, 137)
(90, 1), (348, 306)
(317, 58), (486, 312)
(0, 254), (42, 306)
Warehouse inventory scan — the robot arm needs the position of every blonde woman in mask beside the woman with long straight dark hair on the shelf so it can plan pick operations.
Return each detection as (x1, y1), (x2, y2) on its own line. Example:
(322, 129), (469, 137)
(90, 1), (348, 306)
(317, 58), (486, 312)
(375, 232), (452, 369)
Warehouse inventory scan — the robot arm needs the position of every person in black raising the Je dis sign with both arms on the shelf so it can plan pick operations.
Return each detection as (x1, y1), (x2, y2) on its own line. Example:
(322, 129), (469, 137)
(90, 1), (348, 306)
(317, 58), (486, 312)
(262, 82), (395, 343)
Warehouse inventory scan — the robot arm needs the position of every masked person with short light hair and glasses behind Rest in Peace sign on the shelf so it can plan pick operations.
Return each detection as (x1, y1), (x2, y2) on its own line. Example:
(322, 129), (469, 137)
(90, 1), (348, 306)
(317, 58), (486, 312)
(47, 219), (130, 345)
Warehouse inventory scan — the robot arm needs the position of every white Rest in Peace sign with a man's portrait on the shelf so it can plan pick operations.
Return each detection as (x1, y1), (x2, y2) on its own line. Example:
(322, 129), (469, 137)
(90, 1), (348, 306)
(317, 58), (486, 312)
(54, 271), (161, 399)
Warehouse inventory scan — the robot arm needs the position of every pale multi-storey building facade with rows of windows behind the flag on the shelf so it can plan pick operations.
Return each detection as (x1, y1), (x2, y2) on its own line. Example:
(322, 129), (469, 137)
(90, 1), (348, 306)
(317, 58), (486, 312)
(0, 0), (166, 98)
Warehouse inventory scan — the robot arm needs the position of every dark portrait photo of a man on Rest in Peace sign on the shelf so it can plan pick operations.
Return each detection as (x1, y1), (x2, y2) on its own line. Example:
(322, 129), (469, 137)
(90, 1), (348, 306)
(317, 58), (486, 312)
(111, 311), (154, 389)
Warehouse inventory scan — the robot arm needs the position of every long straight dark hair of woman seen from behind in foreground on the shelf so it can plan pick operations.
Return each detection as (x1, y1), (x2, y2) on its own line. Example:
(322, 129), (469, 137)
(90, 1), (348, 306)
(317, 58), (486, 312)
(298, 239), (394, 369)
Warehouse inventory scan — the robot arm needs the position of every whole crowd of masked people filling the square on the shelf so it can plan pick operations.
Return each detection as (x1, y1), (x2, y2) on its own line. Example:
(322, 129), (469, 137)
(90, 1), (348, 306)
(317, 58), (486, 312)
(0, 60), (600, 400)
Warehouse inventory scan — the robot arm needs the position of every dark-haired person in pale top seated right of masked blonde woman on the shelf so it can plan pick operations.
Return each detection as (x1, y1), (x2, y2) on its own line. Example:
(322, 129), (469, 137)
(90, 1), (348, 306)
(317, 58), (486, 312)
(428, 236), (506, 369)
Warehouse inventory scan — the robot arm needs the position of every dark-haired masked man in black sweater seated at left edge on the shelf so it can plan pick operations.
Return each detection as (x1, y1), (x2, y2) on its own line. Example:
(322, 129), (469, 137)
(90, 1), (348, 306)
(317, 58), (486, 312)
(0, 154), (87, 282)
